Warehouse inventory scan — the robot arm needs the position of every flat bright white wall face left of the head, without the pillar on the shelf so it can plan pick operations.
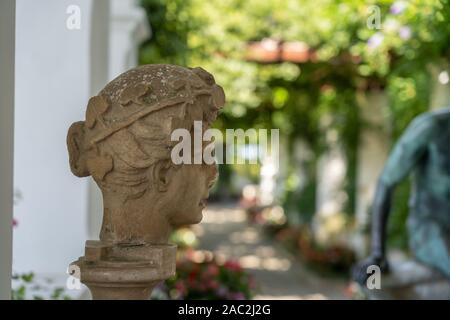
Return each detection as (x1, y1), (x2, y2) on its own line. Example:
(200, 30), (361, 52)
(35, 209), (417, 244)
(13, 0), (91, 273)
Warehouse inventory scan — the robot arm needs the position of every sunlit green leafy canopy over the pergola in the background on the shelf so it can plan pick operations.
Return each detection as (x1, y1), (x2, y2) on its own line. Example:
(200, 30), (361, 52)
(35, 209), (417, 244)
(140, 0), (450, 250)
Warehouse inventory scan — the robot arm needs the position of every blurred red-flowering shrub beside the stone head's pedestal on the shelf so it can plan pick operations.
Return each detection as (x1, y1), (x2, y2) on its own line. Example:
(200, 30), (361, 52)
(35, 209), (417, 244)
(153, 254), (255, 300)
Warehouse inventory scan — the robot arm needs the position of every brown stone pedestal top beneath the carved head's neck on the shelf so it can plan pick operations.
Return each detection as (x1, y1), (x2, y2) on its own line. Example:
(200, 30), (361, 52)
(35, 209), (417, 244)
(72, 241), (176, 300)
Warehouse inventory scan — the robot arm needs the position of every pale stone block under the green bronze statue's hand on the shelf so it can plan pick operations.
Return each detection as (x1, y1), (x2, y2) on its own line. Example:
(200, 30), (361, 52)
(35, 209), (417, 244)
(364, 260), (450, 300)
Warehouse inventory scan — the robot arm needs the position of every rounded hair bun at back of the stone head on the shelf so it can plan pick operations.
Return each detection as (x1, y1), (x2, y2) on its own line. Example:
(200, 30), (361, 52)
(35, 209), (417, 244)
(67, 121), (90, 177)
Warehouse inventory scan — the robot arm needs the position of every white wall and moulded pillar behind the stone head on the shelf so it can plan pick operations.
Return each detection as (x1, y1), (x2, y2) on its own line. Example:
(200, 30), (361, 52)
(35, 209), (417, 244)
(13, 0), (149, 274)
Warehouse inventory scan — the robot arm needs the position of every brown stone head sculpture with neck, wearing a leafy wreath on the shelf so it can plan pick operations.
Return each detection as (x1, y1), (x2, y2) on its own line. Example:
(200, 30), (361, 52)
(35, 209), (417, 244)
(67, 64), (225, 245)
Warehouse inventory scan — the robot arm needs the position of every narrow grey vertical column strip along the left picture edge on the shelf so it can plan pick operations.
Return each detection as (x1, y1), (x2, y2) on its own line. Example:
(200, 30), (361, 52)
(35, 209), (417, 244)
(0, 0), (16, 300)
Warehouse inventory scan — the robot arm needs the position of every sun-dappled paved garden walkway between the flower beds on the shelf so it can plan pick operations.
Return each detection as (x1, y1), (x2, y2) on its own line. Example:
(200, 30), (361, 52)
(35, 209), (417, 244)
(194, 205), (346, 299)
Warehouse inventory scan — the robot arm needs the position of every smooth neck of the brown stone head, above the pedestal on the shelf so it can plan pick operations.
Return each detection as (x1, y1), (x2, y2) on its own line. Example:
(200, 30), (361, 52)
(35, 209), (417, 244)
(100, 201), (172, 244)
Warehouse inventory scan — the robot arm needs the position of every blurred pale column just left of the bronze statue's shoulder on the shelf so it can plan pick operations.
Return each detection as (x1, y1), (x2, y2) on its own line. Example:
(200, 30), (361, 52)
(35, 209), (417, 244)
(353, 91), (389, 256)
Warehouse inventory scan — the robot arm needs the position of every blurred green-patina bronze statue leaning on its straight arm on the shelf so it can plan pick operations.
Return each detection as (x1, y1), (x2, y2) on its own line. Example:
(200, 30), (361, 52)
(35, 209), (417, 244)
(352, 108), (450, 284)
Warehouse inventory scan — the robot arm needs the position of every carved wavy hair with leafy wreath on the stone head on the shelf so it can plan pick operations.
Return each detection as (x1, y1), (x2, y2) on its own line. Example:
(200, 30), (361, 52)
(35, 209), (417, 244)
(67, 64), (225, 198)
